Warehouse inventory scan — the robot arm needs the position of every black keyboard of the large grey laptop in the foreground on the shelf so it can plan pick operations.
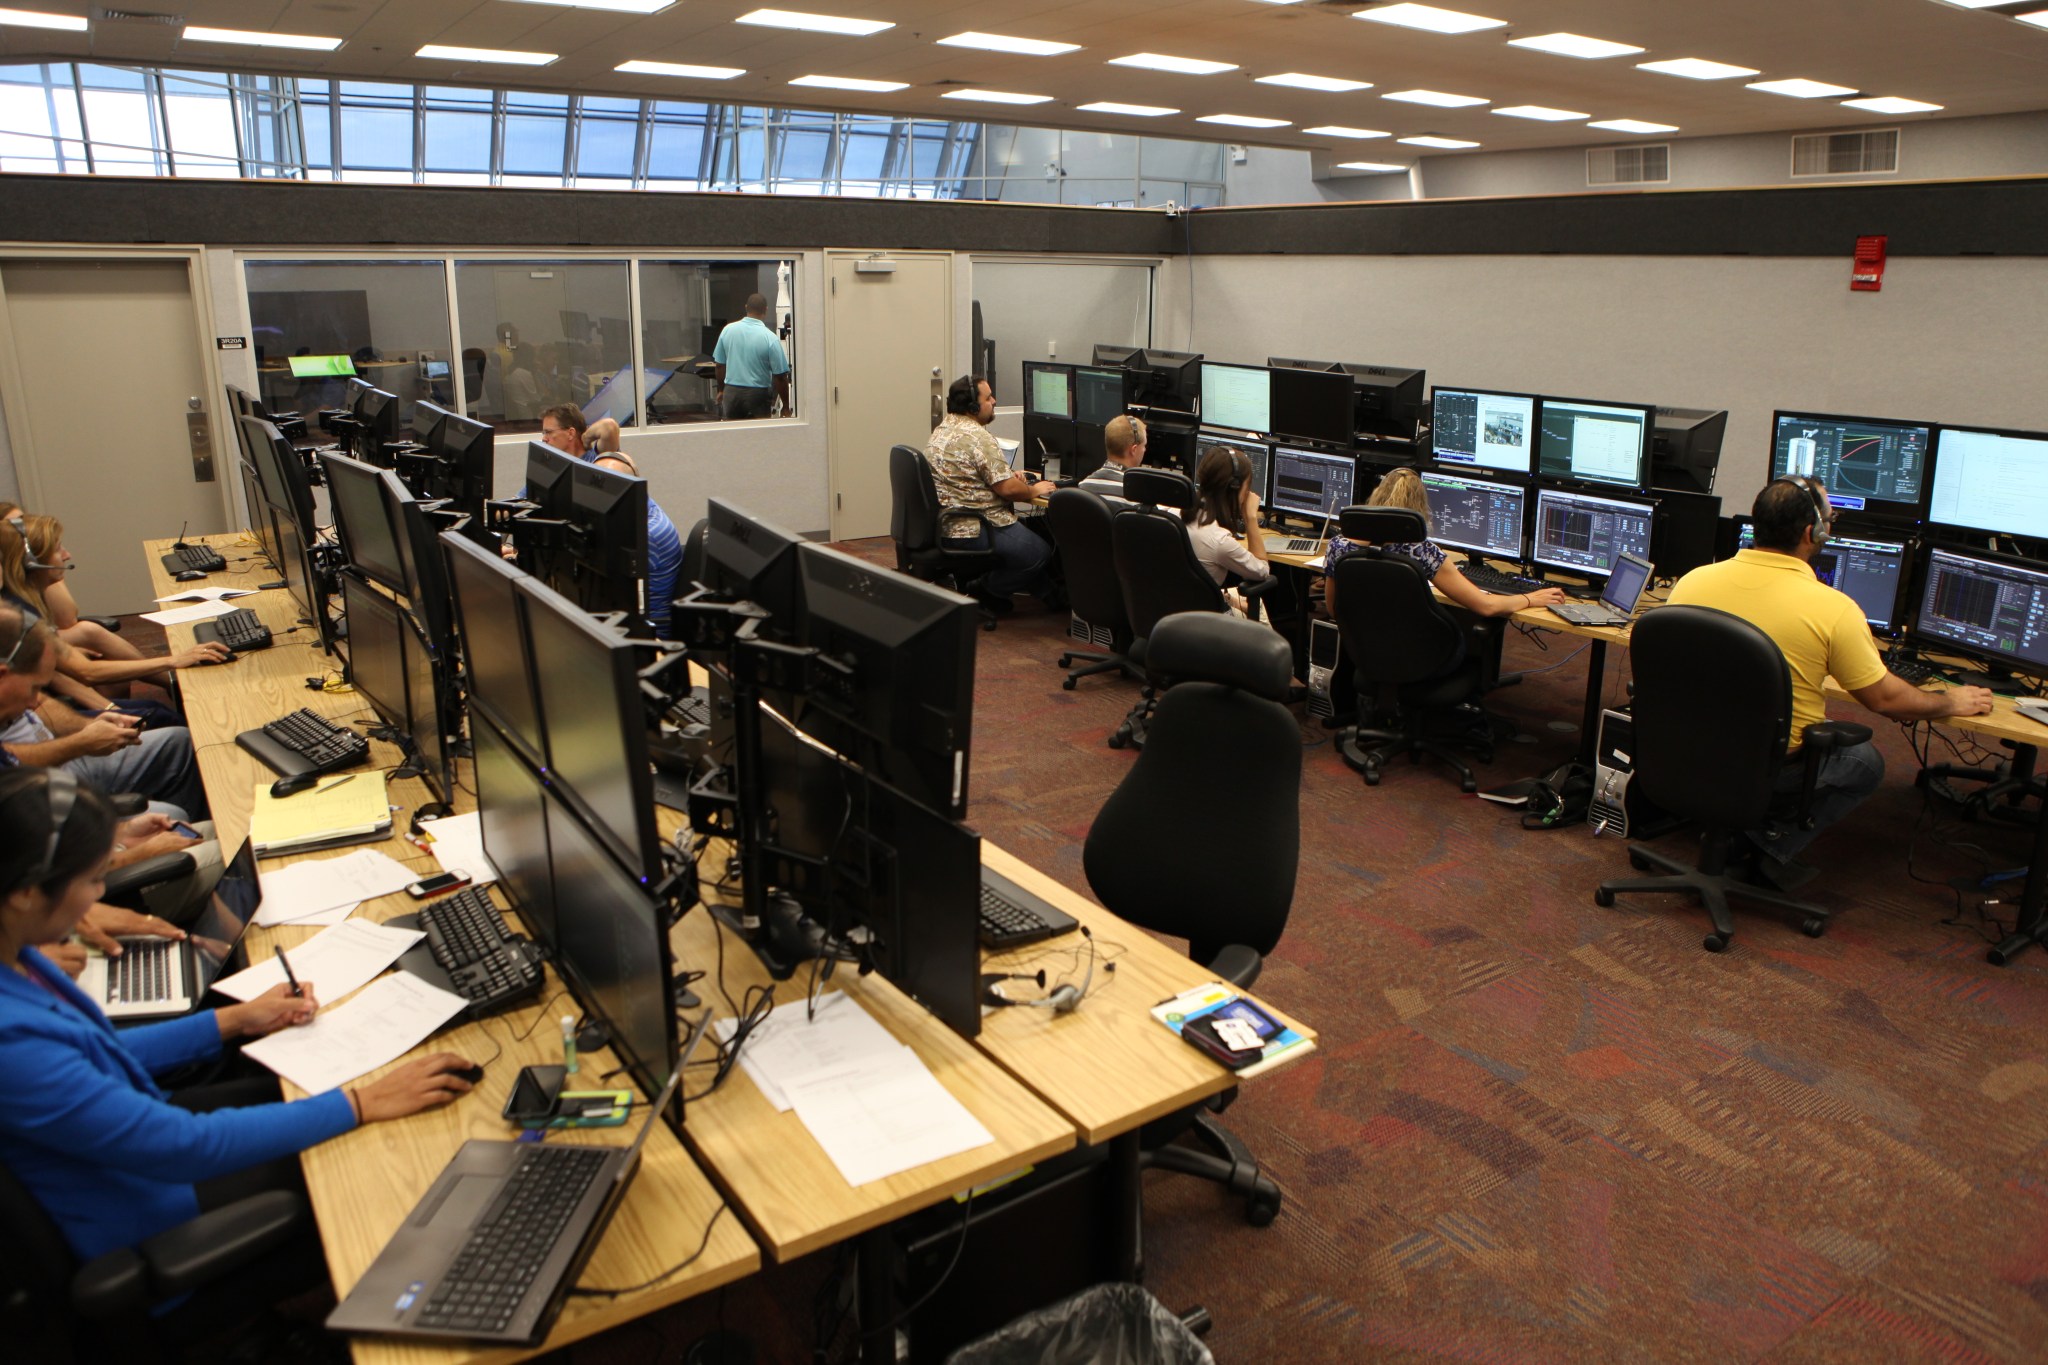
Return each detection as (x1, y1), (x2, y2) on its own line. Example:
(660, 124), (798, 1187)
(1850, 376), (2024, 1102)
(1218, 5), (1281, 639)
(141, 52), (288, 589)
(418, 1144), (610, 1332)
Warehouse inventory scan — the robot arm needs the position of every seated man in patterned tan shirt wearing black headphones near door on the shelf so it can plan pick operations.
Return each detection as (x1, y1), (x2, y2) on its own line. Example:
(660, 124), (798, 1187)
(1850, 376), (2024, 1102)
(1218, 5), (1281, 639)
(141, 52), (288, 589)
(924, 375), (1057, 610)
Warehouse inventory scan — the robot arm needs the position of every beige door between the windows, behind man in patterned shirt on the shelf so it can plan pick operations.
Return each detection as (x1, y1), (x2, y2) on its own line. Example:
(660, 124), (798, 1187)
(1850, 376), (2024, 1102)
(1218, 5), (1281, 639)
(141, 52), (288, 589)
(825, 252), (952, 540)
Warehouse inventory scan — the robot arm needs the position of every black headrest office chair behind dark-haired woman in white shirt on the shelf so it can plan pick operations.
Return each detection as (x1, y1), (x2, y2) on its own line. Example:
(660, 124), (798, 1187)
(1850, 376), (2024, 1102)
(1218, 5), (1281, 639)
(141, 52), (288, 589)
(1110, 469), (1229, 749)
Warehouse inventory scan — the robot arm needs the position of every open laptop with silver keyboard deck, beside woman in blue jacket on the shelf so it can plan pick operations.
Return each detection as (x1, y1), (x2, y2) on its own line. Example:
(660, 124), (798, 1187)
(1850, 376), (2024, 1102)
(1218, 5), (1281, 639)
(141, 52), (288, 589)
(78, 839), (262, 1023)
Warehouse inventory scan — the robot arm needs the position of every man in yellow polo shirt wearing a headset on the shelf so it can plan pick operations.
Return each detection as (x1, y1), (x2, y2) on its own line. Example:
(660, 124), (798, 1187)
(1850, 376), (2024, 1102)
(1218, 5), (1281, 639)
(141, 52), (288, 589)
(1671, 479), (1991, 890)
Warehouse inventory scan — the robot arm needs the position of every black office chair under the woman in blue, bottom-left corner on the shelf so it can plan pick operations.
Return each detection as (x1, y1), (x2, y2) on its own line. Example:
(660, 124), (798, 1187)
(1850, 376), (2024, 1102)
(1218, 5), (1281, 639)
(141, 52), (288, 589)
(0, 1166), (311, 1365)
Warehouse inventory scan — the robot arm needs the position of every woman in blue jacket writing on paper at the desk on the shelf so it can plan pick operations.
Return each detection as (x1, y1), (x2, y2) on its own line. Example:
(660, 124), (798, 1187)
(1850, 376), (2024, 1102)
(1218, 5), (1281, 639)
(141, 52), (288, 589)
(0, 769), (469, 1291)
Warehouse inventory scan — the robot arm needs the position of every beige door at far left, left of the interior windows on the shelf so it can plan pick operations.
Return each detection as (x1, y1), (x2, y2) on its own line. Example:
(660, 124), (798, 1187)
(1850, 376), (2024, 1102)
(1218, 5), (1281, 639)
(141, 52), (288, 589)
(0, 260), (224, 614)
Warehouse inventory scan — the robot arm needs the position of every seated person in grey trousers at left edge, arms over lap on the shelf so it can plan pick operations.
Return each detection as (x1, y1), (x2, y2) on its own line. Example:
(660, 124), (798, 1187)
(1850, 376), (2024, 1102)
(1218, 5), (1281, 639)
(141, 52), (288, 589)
(0, 604), (207, 821)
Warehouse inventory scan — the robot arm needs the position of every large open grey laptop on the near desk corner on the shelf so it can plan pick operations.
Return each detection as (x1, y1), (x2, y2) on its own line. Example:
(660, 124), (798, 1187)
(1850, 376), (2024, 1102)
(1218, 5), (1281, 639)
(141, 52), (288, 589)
(328, 1009), (711, 1347)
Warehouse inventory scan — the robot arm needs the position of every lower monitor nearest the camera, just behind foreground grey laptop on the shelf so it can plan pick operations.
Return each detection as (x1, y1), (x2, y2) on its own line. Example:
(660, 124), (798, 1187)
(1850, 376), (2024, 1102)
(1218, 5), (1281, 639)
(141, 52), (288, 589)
(541, 790), (676, 1095)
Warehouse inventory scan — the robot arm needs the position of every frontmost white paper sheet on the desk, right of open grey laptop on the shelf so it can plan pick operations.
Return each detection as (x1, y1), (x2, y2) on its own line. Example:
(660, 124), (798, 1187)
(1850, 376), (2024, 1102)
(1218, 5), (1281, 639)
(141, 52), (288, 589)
(788, 1048), (995, 1185)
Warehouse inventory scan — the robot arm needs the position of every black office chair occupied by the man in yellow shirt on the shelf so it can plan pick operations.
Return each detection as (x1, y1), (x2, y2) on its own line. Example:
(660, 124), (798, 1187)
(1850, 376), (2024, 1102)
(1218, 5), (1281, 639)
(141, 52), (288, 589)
(1593, 606), (1870, 952)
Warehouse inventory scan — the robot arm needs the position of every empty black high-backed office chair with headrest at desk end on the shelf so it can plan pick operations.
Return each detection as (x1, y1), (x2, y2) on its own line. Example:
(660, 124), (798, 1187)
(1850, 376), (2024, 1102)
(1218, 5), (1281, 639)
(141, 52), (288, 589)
(1081, 613), (1300, 1228)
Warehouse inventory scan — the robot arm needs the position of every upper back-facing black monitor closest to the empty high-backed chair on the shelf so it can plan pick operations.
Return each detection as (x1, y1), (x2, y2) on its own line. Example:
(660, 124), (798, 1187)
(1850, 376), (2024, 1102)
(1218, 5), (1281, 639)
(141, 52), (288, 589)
(797, 544), (981, 819)
